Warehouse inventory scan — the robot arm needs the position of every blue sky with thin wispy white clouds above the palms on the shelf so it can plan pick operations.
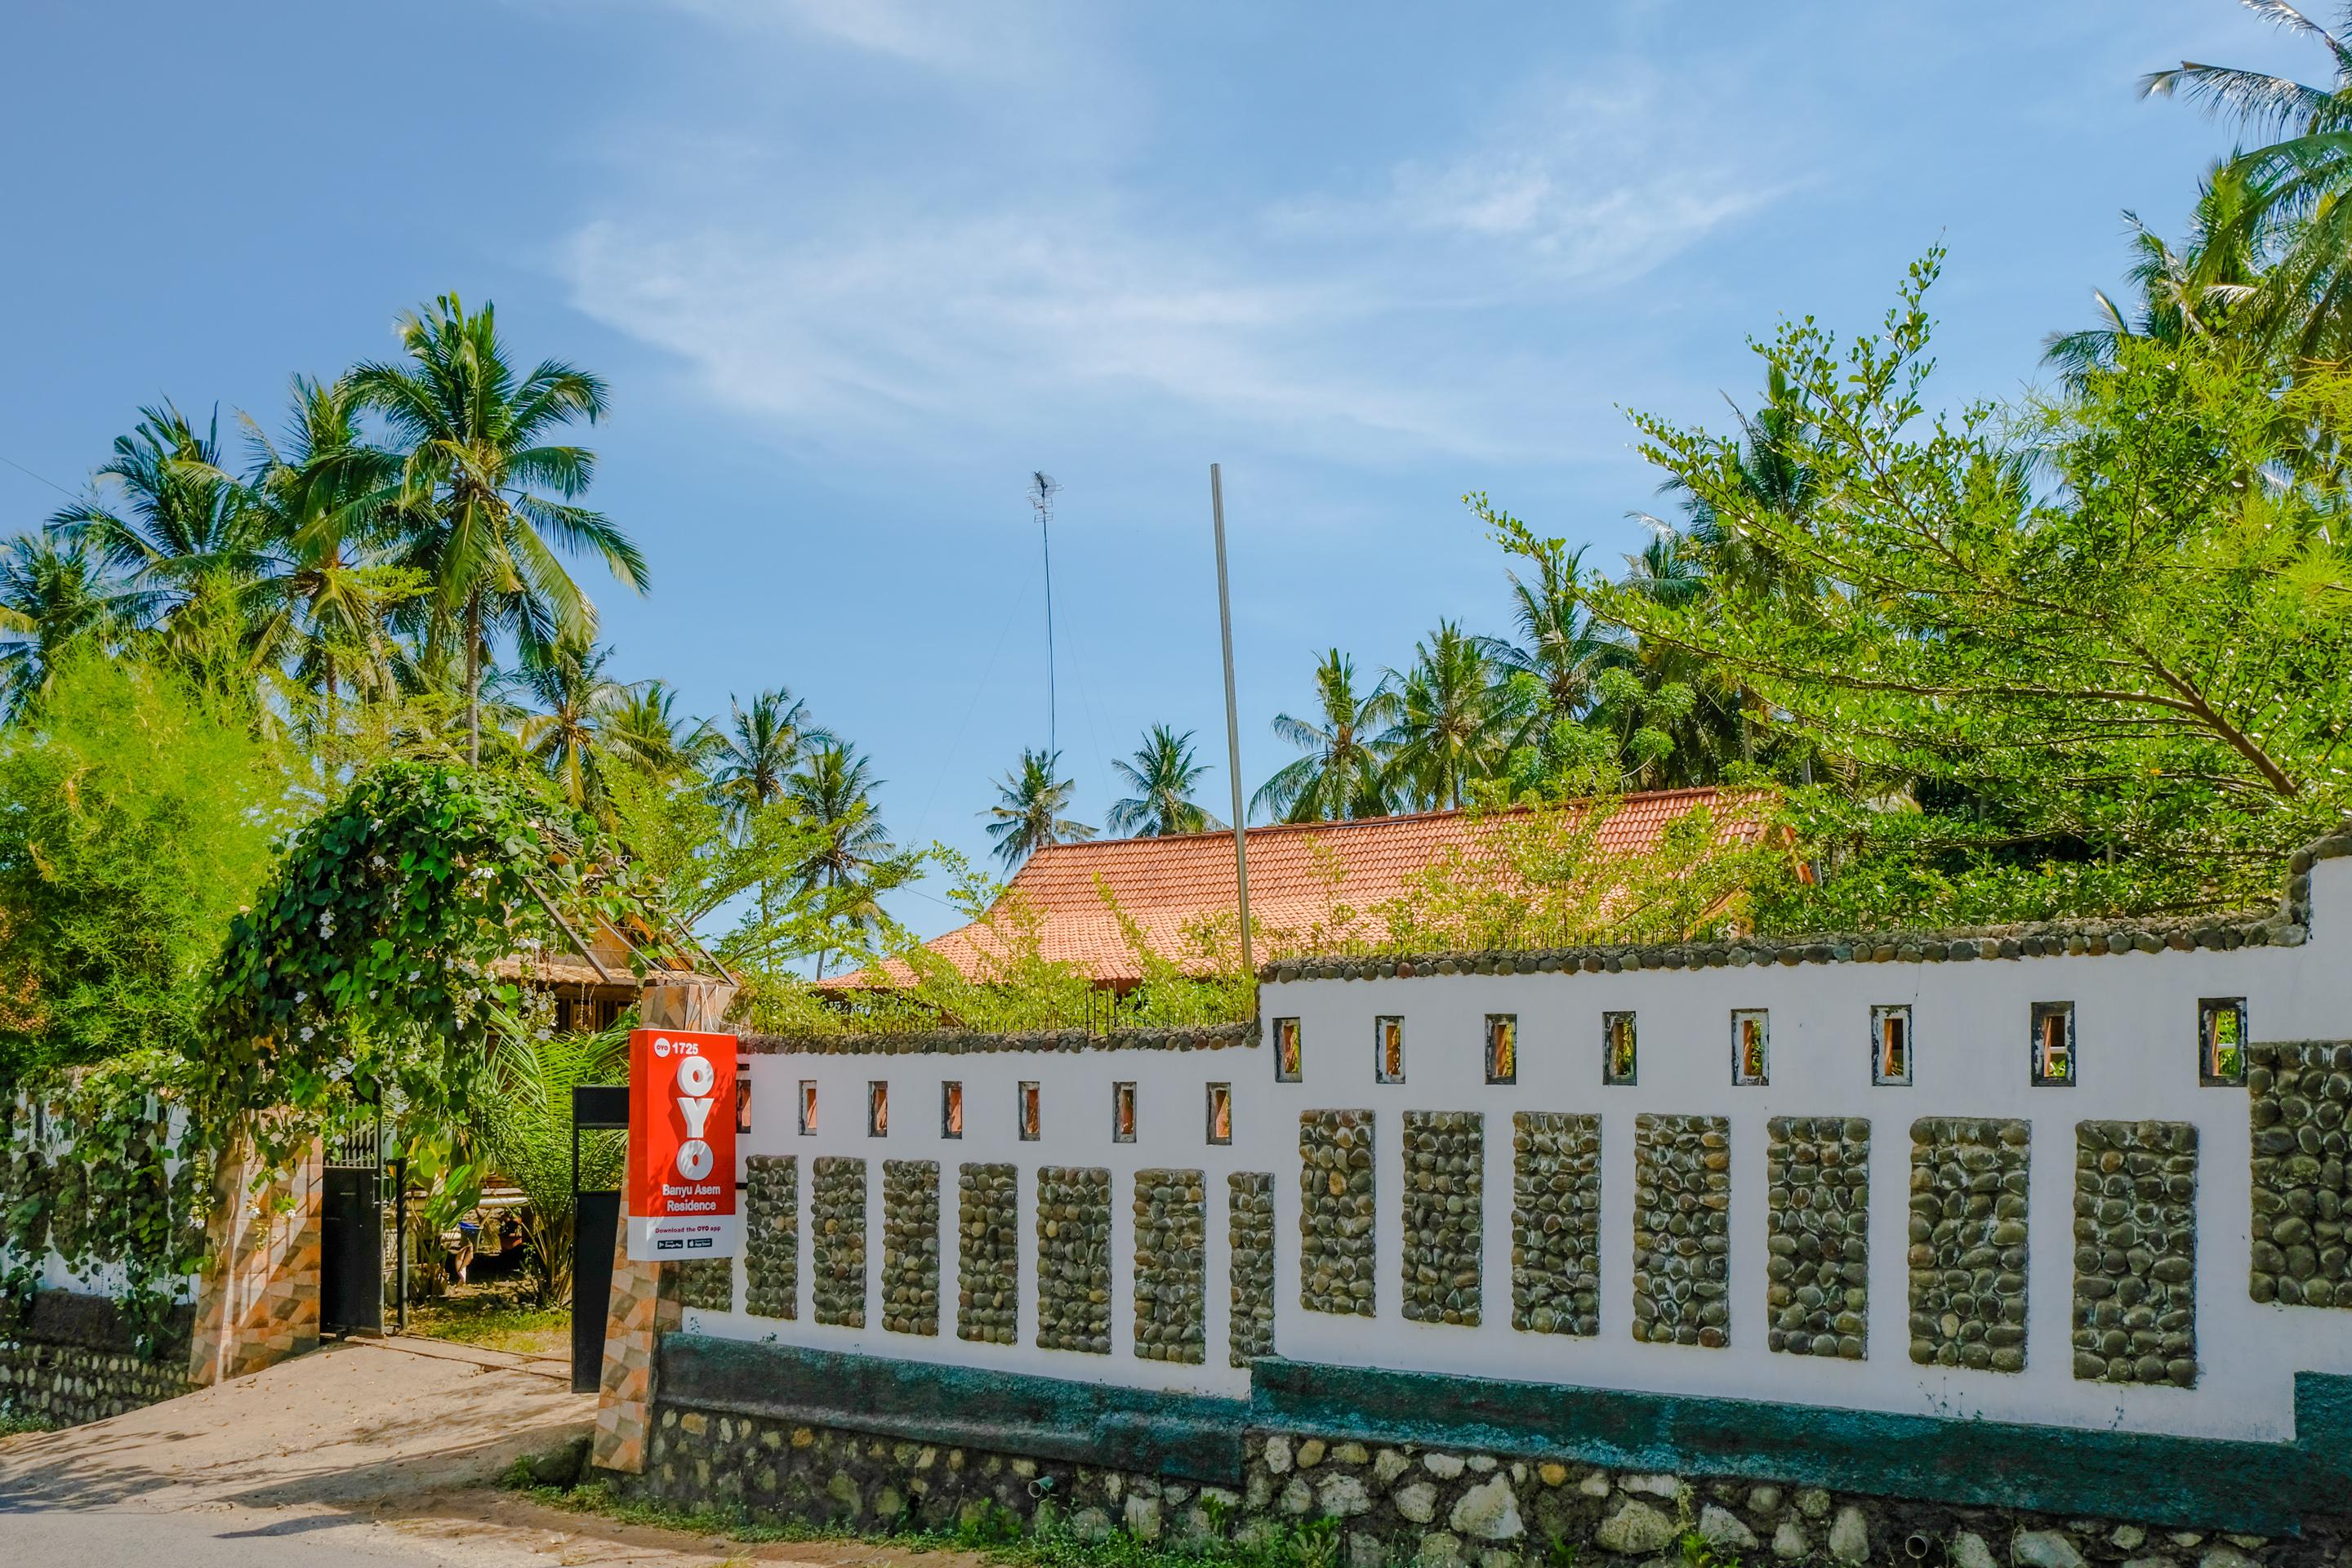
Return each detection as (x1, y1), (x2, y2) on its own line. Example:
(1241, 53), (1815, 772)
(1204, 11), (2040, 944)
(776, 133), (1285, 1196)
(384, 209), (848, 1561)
(0, 0), (2323, 931)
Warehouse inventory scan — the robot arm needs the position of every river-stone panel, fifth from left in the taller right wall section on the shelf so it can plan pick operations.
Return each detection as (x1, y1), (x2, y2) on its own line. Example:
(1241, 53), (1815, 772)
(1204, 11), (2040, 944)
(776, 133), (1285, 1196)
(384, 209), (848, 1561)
(1764, 1116), (1870, 1361)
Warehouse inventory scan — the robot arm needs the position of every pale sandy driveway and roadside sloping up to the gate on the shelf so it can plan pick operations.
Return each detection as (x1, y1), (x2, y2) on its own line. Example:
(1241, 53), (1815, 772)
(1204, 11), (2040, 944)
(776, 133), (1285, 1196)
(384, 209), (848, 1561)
(0, 1338), (978, 1568)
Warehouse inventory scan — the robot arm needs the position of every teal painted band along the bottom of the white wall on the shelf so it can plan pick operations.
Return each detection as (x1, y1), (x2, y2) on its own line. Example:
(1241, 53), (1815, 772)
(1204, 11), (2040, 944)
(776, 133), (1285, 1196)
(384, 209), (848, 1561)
(657, 1335), (2352, 1535)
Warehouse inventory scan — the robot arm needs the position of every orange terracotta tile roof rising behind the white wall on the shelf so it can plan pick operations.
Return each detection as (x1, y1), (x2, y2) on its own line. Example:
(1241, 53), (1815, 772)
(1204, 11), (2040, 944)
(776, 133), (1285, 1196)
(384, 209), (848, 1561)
(821, 790), (1764, 987)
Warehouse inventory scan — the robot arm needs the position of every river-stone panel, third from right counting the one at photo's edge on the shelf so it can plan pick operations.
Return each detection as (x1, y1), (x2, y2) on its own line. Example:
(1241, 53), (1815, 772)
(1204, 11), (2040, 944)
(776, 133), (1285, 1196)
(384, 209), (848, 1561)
(1910, 1116), (2029, 1373)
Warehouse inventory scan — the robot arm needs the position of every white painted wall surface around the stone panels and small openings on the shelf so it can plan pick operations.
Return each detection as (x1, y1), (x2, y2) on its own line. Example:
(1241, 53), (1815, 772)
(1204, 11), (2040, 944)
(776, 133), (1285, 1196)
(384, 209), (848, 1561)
(689, 861), (2352, 1439)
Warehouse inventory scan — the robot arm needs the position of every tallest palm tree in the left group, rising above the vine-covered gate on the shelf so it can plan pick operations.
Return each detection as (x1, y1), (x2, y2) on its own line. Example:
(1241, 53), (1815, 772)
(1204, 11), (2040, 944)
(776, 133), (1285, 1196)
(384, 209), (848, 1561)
(350, 294), (647, 762)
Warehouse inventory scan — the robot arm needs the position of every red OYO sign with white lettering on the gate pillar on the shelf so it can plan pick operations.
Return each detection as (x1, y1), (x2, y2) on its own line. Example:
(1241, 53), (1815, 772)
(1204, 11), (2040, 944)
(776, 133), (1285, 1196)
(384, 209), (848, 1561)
(628, 1030), (743, 1263)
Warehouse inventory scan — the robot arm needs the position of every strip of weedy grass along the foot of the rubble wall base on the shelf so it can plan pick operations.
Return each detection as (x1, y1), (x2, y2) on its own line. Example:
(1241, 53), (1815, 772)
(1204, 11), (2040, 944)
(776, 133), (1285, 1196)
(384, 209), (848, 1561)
(508, 1467), (1341, 1568)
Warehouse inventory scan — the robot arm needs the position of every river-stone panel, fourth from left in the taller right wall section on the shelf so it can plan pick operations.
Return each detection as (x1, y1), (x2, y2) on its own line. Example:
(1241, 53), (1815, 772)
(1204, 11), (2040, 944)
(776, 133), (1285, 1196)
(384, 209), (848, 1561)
(1633, 1112), (1731, 1349)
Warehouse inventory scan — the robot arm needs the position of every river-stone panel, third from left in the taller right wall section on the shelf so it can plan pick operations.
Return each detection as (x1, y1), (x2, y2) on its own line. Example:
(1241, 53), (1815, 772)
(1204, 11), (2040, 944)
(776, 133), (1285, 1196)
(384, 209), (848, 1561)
(1510, 1110), (1601, 1335)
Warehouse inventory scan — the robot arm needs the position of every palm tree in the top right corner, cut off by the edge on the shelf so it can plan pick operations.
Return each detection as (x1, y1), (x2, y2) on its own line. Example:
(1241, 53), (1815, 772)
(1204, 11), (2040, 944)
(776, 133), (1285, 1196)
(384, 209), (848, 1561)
(2140, 0), (2352, 359)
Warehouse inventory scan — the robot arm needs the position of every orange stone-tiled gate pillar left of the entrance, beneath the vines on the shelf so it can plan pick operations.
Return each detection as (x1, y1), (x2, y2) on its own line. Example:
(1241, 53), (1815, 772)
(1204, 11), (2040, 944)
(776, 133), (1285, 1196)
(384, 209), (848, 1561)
(188, 1138), (324, 1387)
